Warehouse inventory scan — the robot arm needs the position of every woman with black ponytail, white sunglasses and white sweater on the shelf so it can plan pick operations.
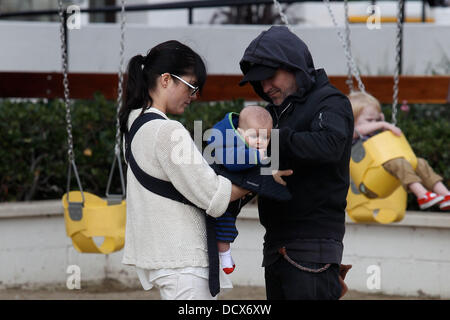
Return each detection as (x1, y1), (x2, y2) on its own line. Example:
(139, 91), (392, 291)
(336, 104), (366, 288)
(119, 40), (247, 299)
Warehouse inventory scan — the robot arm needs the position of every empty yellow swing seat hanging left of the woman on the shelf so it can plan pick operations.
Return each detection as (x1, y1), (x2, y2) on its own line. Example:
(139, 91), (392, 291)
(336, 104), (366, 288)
(62, 191), (126, 254)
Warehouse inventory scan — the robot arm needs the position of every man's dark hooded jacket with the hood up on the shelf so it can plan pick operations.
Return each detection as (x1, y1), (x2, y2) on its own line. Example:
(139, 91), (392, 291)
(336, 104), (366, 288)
(240, 26), (353, 266)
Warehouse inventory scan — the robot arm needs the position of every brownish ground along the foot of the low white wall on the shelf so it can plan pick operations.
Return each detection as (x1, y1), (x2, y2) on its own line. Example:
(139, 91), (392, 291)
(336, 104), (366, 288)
(0, 280), (438, 300)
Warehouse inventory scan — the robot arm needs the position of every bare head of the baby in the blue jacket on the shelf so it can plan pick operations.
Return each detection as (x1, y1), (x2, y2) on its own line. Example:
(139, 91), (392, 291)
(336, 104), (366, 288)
(238, 105), (273, 149)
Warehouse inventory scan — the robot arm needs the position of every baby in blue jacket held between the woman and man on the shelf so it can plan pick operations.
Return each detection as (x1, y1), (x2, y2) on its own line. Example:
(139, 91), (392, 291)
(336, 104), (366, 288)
(208, 105), (272, 274)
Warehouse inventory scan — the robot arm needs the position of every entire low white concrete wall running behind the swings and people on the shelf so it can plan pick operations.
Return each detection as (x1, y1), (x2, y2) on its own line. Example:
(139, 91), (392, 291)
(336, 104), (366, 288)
(0, 201), (450, 299)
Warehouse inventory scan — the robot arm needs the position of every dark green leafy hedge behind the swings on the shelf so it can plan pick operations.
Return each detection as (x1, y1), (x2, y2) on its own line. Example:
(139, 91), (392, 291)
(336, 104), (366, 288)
(0, 95), (450, 209)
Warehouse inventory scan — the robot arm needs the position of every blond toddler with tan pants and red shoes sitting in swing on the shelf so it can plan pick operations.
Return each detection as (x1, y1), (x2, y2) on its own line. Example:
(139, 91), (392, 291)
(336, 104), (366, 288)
(348, 92), (450, 210)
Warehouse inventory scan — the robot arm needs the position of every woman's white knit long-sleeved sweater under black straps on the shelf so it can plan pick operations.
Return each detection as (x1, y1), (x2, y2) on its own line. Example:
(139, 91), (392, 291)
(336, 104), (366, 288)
(122, 108), (231, 269)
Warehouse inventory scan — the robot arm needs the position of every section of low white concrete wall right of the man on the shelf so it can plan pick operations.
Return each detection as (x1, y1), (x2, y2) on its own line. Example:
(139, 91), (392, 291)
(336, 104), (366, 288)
(344, 213), (450, 298)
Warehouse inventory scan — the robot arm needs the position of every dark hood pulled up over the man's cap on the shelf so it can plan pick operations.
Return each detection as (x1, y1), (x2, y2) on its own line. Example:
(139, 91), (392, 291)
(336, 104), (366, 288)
(239, 26), (316, 102)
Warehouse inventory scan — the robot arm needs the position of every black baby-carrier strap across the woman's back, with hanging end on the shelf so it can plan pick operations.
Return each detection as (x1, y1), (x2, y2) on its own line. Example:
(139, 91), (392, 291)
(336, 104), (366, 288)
(125, 112), (220, 297)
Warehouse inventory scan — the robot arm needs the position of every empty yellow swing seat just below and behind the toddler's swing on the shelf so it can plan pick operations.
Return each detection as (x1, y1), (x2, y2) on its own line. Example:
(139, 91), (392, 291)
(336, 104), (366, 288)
(346, 181), (407, 224)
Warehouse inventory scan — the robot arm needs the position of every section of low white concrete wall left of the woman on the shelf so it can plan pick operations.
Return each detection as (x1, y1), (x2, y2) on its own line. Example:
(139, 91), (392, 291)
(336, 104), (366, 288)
(0, 201), (138, 288)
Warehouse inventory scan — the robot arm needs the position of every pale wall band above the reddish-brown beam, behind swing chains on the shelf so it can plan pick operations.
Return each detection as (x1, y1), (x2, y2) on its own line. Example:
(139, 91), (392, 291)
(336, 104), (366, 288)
(0, 22), (450, 75)
